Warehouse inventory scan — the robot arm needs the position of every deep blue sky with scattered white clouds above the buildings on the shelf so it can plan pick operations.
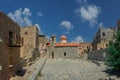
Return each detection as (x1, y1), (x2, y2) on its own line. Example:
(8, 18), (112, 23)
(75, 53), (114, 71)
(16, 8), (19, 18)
(0, 0), (120, 42)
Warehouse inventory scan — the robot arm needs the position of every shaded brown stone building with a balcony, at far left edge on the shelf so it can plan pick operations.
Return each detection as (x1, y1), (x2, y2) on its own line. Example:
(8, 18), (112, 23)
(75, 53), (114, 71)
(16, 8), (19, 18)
(0, 12), (23, 80)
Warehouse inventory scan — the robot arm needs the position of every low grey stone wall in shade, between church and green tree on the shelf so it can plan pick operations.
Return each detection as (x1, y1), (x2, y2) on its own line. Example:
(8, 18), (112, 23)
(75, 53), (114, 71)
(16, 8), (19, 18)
(88, 49), (108, 61)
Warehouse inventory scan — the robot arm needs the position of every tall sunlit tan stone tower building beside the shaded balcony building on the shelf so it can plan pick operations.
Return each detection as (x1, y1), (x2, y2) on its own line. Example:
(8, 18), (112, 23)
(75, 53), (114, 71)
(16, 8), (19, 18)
(20, 26), (39, 65)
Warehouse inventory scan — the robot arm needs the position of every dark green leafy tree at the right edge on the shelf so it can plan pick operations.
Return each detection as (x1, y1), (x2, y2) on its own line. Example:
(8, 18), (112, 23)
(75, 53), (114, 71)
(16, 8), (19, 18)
(107, 31), (120, 70)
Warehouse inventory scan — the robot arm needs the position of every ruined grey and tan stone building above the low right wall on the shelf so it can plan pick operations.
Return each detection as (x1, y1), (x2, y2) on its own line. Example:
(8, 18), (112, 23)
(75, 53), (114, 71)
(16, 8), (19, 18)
(92, 27), (115, 50)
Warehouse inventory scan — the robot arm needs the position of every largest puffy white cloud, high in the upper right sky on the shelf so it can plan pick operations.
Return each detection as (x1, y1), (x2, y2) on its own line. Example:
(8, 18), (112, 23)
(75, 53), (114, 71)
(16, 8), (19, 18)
(75, 0), (101, 27)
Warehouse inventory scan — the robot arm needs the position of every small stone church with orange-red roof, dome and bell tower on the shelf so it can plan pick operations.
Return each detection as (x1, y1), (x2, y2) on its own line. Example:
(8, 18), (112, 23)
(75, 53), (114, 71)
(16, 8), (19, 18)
(47, 35), (80, 58)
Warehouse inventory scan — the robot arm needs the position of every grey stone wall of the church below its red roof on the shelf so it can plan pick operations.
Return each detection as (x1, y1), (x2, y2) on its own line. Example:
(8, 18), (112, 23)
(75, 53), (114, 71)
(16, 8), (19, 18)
(48, 47), (80, 58)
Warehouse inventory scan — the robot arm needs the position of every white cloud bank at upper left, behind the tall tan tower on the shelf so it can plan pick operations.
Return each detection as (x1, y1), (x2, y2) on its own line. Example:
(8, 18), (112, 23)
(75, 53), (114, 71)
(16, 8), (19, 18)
(8, 8), (42, 33)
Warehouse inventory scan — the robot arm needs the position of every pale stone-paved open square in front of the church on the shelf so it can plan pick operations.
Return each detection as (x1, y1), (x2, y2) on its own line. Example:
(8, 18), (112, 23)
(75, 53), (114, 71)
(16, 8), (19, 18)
(39, 59), (119, 80)
